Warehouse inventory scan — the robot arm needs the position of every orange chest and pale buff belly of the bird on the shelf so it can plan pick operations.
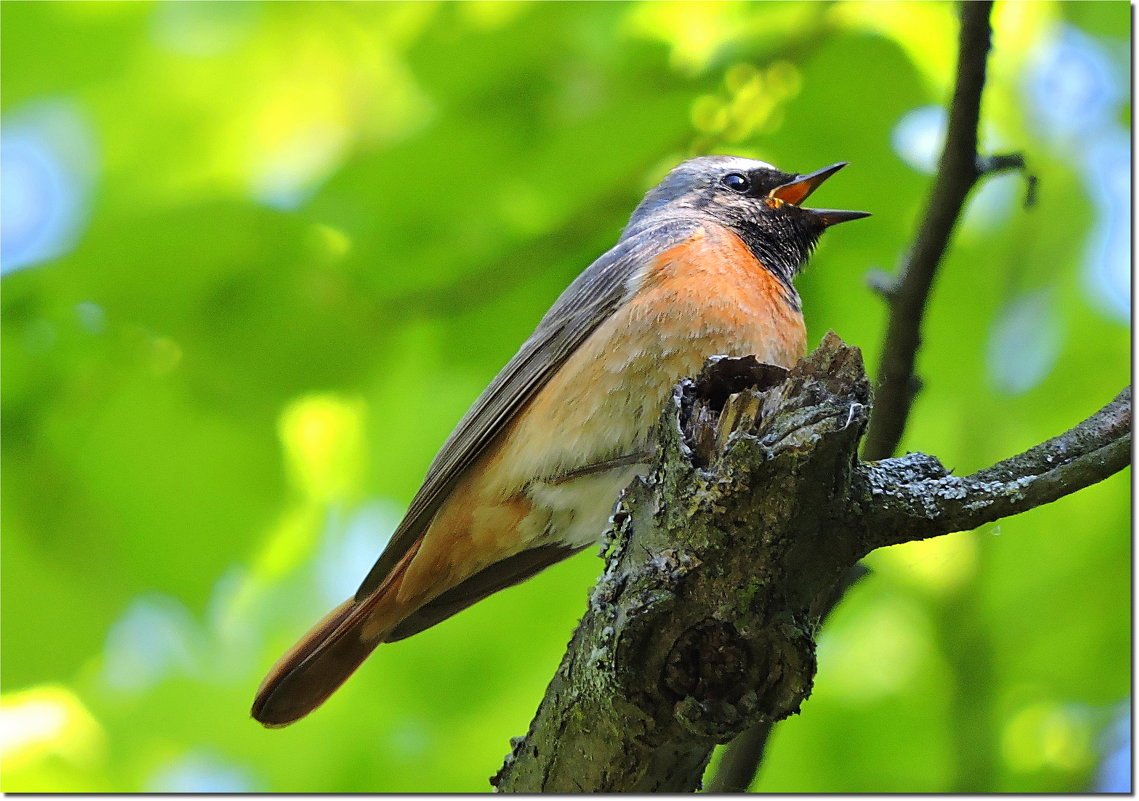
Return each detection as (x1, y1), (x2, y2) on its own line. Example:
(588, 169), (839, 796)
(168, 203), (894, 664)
(502, 226), (806, 494)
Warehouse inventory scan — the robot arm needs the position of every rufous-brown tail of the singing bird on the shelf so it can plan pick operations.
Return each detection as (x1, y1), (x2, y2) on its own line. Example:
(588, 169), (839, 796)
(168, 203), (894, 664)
(252, 542), (419, 728)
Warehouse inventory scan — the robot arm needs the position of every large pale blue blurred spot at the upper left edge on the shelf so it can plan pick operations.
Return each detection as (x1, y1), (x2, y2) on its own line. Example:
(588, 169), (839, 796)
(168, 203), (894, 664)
(0, 100), (95, 273)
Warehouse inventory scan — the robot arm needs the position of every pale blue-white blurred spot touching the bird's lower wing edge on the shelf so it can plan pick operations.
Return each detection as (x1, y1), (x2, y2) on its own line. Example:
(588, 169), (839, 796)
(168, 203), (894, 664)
(317, 500), (402, 604)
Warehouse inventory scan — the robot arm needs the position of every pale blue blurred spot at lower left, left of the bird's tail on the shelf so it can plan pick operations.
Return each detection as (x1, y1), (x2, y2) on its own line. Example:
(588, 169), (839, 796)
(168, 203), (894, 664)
(103, 594), (200, 693)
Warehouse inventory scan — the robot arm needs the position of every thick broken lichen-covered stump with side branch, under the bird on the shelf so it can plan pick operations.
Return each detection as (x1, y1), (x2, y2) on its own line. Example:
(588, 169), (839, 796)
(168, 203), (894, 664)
(492, 334), (1131, 792)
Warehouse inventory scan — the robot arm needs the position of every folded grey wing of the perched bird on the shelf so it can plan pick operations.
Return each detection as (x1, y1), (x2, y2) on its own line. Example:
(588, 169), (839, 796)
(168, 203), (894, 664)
(355, 220), (698, 600)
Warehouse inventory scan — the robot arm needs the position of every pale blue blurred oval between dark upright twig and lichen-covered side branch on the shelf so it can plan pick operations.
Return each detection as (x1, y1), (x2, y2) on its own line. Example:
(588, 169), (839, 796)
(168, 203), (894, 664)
(986, 289), (1060, 395)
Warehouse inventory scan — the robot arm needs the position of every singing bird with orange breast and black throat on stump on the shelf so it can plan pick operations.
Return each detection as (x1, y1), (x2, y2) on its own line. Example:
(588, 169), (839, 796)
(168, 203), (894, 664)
(252, 155), (869, 728)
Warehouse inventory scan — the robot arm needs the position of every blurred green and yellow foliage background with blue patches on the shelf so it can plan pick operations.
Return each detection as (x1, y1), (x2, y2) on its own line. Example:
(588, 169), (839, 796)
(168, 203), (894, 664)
(0, 2), (1131, 792)
